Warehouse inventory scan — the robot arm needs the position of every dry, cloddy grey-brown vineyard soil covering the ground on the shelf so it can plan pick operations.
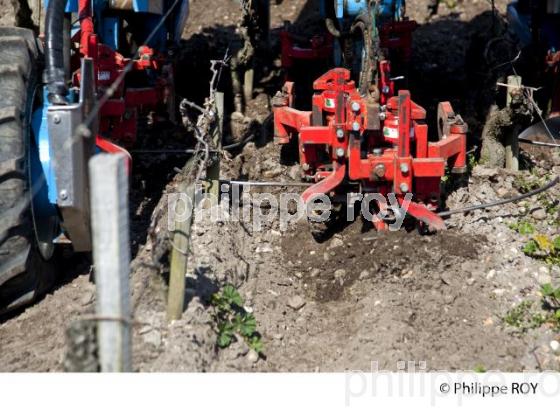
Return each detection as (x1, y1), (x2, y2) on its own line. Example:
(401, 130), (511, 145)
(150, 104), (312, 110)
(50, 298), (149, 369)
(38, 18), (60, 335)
(0, 0), (560, 372)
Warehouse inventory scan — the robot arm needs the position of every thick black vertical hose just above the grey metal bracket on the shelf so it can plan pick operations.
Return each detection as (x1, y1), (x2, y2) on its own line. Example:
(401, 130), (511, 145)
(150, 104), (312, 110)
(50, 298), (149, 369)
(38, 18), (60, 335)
(45, 0), (68, 105)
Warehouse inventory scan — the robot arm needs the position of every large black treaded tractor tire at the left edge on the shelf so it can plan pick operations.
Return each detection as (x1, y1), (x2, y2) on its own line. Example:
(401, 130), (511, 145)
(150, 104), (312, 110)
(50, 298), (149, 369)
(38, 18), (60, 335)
(0, 27), (55, 313)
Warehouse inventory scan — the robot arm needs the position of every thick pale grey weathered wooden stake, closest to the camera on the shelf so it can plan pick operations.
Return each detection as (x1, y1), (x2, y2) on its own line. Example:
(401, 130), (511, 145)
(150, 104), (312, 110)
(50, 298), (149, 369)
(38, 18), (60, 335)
(89, 154), (132, 372)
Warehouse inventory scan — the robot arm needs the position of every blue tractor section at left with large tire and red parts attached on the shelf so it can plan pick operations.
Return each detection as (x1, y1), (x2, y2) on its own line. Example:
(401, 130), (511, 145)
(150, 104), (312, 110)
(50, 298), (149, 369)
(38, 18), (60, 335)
(0, 0), (189, 313)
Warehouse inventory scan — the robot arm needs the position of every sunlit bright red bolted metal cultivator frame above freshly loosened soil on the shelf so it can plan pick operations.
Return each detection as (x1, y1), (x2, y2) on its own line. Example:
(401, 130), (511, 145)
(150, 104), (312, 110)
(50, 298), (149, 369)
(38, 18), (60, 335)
(274, 63), (467, 229)
